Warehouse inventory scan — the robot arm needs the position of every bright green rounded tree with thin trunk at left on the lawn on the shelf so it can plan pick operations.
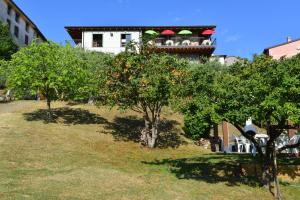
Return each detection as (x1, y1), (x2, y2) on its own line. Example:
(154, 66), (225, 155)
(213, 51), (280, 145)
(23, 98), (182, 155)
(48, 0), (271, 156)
(8, 42), (86, 116)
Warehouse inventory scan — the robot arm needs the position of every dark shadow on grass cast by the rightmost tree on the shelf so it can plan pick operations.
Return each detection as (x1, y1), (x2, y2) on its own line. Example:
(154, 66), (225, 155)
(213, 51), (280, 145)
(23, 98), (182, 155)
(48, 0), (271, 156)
(142, 155), (260, 187)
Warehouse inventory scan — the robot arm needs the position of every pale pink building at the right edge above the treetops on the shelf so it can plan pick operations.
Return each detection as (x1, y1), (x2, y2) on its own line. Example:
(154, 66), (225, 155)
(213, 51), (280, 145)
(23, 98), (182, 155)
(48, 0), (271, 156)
(264, 37), (300, 60)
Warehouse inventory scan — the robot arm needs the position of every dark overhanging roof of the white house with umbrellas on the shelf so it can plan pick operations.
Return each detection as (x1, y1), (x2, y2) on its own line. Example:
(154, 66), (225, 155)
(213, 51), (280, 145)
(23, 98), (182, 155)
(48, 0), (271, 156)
(65, 25), (216, 40)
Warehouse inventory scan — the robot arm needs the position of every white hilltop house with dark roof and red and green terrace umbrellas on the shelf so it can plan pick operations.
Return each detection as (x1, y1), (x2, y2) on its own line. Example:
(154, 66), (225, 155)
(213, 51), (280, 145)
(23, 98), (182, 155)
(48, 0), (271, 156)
(65, 26), (216, 58)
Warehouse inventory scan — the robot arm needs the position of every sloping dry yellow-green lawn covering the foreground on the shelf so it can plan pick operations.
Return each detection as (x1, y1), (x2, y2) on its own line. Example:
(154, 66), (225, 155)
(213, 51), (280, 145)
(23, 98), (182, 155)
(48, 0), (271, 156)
(0, 101), (300, 200)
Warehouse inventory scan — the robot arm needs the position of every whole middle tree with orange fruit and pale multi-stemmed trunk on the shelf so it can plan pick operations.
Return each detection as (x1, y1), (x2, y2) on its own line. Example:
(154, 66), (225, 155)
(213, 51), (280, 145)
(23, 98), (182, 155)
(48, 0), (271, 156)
(106, 48), (187, 148)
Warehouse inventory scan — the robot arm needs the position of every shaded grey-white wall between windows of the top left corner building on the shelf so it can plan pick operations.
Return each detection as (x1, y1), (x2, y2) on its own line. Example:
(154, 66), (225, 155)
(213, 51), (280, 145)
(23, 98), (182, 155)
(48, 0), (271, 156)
(0, 0), (36, 47)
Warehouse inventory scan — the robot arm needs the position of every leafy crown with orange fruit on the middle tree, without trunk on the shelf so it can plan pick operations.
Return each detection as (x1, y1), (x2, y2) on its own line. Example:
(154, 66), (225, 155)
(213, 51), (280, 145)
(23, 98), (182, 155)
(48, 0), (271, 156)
(106, 50), (185, 110)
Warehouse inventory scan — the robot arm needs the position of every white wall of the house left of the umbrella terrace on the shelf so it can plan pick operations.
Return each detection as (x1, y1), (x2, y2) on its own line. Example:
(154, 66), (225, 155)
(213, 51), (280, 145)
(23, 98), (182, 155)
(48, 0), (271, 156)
(82, 31), (141, 54)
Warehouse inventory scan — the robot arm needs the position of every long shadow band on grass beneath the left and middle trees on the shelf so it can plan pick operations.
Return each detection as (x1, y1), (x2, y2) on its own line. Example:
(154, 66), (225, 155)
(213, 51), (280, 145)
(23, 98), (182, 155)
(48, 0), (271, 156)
(24, 107), (186, 148)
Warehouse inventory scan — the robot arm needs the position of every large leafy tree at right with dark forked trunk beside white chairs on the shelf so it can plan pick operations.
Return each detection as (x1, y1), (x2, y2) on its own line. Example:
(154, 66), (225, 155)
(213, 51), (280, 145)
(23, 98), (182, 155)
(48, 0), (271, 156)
(179, 56), (300, 192)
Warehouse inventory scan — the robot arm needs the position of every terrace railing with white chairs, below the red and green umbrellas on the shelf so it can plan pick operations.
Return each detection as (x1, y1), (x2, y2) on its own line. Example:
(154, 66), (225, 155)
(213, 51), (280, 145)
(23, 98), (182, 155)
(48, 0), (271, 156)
(150, 37), (217, 48)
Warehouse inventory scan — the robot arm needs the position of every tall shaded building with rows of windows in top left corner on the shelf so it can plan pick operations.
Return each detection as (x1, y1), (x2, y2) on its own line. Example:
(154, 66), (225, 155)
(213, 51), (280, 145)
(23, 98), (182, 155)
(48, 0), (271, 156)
(0, 0), (46, 47)
